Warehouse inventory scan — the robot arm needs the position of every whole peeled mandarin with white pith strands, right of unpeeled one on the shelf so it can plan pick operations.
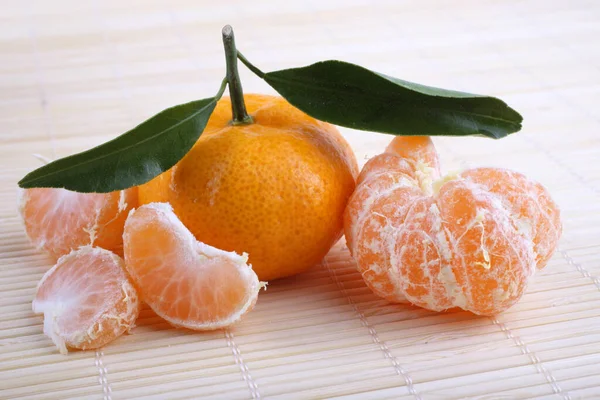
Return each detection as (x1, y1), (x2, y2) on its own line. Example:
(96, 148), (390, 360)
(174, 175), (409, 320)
(344, 137), (562, 315)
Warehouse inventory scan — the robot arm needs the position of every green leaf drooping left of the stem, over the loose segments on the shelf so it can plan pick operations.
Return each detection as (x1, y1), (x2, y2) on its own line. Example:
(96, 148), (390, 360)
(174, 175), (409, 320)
(19, 97), (224, 193)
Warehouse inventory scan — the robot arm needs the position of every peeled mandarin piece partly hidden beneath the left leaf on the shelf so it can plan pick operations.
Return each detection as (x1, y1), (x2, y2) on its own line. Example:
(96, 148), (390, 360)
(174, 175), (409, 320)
(20, 188), (137, 260)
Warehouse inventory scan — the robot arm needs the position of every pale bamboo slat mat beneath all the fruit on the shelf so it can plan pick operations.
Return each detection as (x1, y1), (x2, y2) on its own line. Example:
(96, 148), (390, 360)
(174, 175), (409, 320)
(0, 0), (600, 399)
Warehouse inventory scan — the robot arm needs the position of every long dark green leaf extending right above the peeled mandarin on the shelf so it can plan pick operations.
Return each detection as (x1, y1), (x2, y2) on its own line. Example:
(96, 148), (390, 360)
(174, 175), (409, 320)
(260, 56), (523, 139)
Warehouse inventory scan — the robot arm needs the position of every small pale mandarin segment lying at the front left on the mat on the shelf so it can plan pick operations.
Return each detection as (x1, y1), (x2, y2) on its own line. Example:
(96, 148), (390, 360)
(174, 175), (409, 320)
(33, 246), (141, 353)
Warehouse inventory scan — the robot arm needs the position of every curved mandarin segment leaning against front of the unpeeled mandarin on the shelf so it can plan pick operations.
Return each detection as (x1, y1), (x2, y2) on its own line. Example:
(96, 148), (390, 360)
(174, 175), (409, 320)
(123, 203), (262, 330)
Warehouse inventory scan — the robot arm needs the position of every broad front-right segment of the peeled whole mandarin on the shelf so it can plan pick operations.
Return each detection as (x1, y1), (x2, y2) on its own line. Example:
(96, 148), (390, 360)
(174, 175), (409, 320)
(437, 179), (535, 315)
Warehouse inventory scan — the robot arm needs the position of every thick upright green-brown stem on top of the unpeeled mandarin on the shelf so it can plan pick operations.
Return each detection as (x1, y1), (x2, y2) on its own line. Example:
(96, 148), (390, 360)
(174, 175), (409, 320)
(222, 25), (253, 125)
